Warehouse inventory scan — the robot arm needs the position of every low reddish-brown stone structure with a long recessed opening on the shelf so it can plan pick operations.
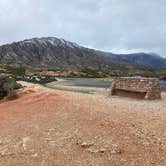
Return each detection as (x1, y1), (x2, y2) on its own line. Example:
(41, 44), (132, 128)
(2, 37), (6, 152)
(111, 77), (161, 100)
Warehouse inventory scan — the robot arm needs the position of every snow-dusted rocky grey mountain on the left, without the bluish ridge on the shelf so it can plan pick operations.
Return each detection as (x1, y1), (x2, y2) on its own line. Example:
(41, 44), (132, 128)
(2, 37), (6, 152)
(0, 38), (127, 71)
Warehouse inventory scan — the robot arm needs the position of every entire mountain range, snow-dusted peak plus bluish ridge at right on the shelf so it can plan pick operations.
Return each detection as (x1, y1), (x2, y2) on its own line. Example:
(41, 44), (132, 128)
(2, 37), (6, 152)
(0, 37), (166, 75)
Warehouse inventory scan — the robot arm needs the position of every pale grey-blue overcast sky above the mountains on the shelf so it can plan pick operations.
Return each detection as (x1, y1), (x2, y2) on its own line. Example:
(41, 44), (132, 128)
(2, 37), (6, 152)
(0, 0), (166, 57)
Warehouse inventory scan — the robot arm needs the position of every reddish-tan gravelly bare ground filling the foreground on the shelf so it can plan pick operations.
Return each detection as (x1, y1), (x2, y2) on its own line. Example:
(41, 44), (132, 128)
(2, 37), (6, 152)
(0, 82), (166, 166)
